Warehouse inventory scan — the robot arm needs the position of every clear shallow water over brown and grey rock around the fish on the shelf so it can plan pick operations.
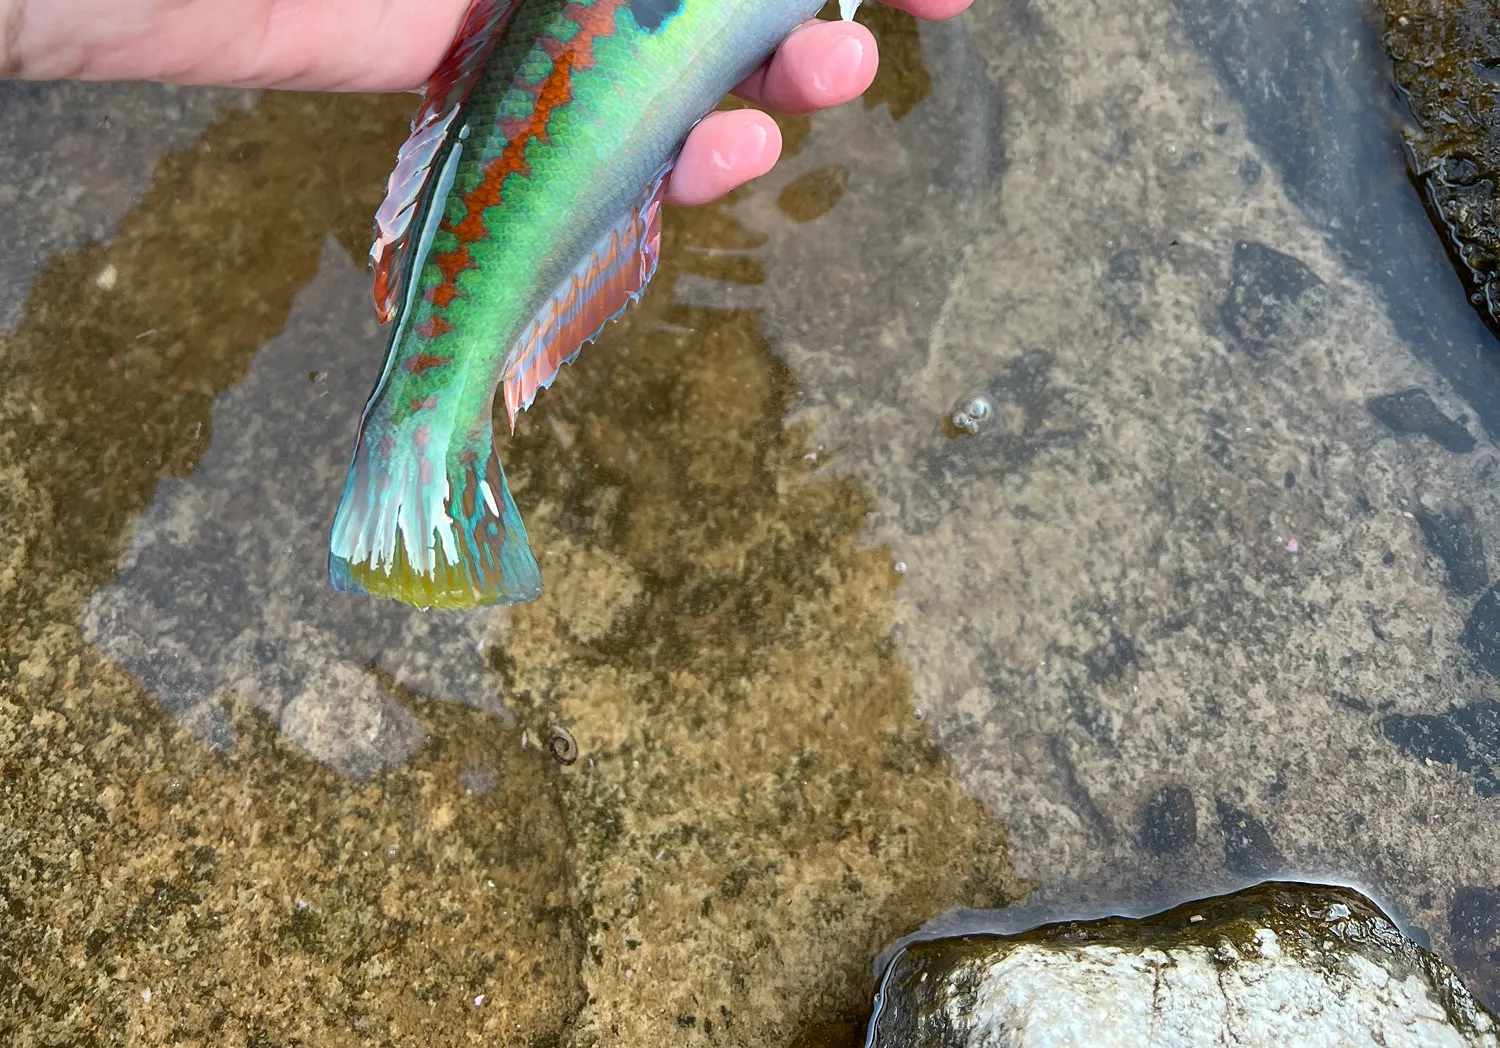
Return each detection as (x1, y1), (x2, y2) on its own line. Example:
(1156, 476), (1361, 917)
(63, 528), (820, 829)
(0, 0), (1500, 1045)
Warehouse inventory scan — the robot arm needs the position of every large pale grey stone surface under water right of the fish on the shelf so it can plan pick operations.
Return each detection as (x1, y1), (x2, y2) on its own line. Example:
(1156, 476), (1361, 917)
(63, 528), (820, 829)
(747, 0), (1500, 1019)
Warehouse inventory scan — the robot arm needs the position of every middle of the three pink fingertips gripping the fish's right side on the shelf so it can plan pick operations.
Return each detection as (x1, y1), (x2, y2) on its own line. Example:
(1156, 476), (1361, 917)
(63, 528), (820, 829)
(735, 21), (879, 112)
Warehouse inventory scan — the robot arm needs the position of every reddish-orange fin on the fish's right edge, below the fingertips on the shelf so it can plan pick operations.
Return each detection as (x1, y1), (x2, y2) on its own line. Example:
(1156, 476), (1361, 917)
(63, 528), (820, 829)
(503, 160), (677, 432)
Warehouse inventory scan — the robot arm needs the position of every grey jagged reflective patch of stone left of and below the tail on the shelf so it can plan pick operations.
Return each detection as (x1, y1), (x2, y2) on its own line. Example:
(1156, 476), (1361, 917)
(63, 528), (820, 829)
(81, 240), (507, 778)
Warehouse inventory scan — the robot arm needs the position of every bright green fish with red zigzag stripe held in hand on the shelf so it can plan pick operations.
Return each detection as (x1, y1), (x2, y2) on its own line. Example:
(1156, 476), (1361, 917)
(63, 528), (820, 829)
(329, 0), (860, 609)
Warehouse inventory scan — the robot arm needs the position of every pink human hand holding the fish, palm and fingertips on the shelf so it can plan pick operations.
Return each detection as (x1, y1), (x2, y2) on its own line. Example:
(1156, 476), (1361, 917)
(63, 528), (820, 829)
(0, 0), (971, 204)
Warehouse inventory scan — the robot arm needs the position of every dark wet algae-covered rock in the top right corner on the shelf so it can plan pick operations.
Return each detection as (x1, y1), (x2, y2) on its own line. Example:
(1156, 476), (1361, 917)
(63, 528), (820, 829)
(1383, 0), (1500, 328)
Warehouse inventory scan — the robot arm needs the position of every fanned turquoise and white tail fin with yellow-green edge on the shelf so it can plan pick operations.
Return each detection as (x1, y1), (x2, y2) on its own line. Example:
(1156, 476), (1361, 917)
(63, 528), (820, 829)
(329, 420), (542, 609)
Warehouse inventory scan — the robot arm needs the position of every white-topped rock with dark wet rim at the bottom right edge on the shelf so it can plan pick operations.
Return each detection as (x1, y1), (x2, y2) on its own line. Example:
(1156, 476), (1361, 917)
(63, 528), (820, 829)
(869, 882), (1497, 1048)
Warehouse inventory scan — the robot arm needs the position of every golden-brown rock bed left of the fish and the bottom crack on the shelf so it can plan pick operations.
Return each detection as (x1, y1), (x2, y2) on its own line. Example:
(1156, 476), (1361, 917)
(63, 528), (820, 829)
(0, 94), (594, 1045)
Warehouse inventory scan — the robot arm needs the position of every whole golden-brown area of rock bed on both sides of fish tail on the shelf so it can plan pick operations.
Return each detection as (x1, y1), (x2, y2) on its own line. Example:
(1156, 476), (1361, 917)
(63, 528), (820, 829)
(0, 12), (1025, 1047)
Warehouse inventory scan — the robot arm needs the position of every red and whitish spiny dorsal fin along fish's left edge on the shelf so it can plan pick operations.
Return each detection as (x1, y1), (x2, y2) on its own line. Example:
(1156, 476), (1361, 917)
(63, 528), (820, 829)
(371, 0), (522, 324)
